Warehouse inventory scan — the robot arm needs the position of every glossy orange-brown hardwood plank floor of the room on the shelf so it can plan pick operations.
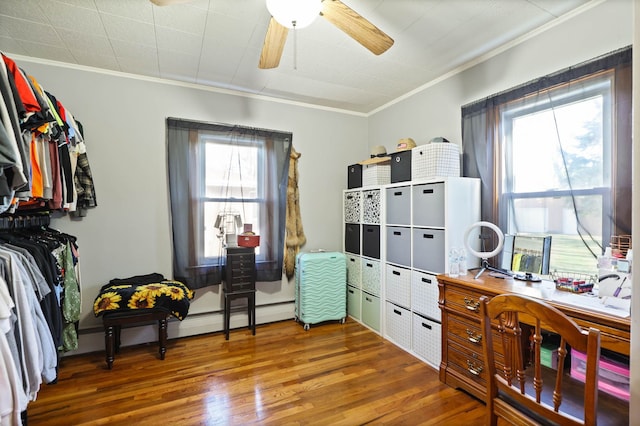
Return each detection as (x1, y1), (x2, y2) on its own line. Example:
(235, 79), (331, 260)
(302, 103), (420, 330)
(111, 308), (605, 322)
(28, 319), (485, 426)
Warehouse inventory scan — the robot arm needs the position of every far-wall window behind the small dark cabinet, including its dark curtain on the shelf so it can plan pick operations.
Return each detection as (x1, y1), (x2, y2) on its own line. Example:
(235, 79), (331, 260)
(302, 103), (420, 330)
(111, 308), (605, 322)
(167, 118), (291, 288)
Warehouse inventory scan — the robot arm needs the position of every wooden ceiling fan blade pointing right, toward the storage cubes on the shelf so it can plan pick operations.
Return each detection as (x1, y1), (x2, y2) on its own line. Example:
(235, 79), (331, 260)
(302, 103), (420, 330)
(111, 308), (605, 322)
(320, 0), (393, 55)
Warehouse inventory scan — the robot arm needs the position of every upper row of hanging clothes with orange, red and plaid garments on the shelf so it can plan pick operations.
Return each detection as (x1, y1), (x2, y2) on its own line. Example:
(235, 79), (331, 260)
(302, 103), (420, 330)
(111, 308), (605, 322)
(0, 52), (97, 216)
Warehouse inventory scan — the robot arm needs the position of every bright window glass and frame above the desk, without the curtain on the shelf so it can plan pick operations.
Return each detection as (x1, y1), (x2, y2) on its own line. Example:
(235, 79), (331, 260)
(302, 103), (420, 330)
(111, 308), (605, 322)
(499, 72), (613, 273)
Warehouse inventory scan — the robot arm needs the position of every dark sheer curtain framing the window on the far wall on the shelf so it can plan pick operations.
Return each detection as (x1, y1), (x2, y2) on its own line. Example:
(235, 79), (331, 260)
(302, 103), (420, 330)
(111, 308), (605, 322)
(167, 118), (292, 289)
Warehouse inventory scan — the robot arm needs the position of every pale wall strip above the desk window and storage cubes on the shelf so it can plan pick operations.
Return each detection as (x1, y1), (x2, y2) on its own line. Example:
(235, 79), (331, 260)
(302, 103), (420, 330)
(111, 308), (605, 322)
(369, 0), (632, 151)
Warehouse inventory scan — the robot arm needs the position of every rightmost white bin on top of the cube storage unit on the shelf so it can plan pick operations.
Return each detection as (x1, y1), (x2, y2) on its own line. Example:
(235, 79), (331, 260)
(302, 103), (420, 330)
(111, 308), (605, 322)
(411, 142), (460, 180)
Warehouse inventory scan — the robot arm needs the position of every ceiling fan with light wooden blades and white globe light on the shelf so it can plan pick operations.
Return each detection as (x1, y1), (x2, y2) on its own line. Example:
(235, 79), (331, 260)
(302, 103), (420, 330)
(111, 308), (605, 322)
(150, 0), (393, 69)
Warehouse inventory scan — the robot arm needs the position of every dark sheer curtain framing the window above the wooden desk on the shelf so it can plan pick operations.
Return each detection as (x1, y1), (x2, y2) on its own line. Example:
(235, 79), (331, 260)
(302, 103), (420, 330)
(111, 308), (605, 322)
(462, 46), (632, 251)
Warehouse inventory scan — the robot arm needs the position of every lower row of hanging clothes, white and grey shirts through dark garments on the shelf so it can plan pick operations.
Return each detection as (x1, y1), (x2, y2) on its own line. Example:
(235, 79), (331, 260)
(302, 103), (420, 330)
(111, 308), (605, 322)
(0, 225), (81, 424)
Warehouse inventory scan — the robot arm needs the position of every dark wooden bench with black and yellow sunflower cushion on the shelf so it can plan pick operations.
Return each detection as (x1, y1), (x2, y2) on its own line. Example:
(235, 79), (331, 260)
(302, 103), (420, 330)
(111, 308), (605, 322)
(93, 273), (193, 369)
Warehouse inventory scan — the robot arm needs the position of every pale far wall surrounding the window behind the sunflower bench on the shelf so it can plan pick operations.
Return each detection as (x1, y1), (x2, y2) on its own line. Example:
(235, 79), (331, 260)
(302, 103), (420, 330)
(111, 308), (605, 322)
(14, 58), (368, 352)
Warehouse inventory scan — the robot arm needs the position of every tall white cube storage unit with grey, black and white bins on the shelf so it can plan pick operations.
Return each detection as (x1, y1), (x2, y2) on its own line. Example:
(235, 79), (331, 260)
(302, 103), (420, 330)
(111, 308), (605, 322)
(344, 176), (480, 362)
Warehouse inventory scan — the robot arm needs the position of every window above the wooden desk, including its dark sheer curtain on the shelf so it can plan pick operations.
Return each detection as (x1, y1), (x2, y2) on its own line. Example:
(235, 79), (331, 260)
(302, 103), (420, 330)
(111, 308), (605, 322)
(462, 47), (631, 274)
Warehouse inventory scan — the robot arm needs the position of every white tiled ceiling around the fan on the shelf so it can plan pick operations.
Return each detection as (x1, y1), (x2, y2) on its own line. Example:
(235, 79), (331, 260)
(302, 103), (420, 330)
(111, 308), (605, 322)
(0, 0), (601, 113)
